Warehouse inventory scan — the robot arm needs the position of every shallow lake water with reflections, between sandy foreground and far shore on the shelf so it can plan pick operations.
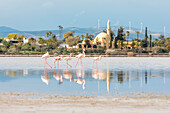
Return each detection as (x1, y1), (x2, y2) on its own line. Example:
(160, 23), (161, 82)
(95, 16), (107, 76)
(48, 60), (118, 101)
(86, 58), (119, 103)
(0, 57), (170, 96)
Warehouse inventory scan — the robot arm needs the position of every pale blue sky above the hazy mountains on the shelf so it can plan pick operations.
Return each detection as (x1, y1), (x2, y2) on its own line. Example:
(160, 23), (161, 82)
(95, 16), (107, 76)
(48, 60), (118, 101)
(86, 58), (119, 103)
(0, 0), (170, 32)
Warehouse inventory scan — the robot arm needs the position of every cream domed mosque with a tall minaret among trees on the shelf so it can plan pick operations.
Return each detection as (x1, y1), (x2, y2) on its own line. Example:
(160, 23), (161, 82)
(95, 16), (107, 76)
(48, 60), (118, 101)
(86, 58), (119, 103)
(77, 20), (111, 49)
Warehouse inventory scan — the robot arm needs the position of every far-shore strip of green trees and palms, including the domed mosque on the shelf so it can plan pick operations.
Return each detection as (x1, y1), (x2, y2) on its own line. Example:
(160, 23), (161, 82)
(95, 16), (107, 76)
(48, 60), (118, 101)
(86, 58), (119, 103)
(0, 20), (170, 57)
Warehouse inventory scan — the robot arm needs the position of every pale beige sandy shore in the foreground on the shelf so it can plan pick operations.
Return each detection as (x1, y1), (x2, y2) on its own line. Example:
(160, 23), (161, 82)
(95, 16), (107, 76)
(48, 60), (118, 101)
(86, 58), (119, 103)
(0, 93), (170, 113)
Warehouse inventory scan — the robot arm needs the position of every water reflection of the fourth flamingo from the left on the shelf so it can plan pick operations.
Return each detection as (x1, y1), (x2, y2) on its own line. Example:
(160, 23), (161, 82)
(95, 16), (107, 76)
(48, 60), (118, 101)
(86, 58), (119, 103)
(74, 69), (86, 90)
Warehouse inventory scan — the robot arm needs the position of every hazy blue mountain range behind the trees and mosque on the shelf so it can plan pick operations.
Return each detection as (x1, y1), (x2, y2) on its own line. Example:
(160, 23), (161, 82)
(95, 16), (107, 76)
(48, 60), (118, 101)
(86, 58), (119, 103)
(0, 26), (170, 39)
